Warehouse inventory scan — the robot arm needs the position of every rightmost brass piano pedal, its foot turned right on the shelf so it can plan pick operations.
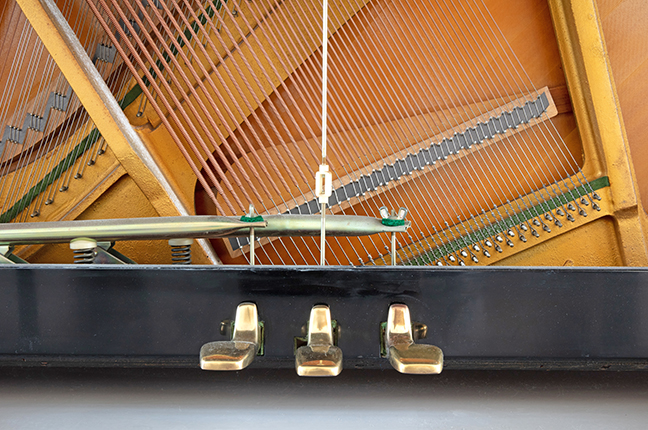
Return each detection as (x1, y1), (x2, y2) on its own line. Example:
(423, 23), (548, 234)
(385, 304), (443, 374)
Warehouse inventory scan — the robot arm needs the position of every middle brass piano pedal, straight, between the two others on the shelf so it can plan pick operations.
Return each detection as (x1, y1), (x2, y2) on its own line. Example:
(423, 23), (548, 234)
(295, 305), (342, 376)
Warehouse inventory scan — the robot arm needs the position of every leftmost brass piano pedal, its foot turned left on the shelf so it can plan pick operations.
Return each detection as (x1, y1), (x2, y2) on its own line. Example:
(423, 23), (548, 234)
(200, 303), (261, 370)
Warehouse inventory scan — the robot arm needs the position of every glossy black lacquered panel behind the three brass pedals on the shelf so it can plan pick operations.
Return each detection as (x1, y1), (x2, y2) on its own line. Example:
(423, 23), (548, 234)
(0, 266), (648, 368)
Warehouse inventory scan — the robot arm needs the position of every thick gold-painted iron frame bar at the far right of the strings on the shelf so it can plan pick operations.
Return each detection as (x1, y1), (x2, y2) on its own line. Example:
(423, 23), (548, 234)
(549, 0), (648, 266)
